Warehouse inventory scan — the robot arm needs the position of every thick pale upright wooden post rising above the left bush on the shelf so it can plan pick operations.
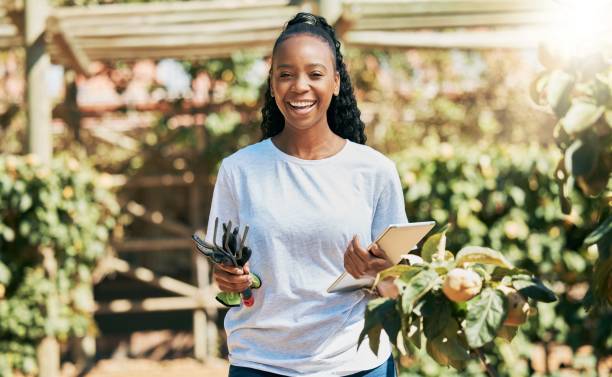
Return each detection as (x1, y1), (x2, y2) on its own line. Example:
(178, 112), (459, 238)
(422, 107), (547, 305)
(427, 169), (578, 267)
(24, 0), (53, 161)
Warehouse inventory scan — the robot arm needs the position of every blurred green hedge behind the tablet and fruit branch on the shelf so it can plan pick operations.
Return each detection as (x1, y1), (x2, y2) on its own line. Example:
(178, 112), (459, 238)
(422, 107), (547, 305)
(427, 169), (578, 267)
(384, 136), (612, 375)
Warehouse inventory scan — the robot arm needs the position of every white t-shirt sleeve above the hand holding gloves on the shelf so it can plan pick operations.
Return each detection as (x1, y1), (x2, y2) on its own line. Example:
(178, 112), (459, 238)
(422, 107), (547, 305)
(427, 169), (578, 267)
(206, 162), (240, 243)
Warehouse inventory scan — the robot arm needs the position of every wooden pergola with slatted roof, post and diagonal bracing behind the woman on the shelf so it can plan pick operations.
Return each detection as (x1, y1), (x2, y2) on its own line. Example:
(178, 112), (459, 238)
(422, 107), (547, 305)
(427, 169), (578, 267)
(0, 0), (612, 377)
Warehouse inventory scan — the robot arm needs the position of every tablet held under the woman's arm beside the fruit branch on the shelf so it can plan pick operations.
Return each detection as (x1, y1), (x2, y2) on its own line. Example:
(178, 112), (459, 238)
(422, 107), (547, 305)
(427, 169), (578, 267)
(327, 221), (436, 293)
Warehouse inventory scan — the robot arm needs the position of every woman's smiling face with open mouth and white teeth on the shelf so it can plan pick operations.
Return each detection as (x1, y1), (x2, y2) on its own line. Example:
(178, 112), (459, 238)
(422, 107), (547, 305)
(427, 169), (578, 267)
(270, 34), (340, 130)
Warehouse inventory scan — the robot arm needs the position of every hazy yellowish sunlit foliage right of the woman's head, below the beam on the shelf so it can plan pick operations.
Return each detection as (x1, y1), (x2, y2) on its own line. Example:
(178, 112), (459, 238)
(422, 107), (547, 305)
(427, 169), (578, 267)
(346, 49), (550, 153)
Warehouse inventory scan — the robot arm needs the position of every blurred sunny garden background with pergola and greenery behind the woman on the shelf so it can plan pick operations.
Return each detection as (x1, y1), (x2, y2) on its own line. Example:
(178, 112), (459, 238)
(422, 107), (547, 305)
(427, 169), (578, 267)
(0, 0), (612, 377)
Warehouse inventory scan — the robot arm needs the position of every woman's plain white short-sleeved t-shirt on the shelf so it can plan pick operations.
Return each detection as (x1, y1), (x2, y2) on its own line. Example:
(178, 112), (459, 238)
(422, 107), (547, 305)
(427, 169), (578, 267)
(206, 139), (407, 376)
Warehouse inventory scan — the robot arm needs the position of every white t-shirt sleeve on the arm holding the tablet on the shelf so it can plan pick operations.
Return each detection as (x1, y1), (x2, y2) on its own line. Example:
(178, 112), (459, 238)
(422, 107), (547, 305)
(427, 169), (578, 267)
(372, 168), (408, 242)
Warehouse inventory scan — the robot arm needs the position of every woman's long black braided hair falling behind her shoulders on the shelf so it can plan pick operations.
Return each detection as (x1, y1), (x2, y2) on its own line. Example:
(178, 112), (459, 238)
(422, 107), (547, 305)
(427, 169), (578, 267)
(261, 12), (366, 144)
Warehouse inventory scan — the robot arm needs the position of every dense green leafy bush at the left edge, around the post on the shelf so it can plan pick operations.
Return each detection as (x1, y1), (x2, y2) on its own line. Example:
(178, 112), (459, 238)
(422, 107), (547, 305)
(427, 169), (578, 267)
(0, 155), (118, 375)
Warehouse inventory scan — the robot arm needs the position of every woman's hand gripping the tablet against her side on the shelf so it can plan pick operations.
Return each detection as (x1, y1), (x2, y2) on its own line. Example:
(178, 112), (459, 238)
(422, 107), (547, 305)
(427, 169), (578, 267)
(344, 236), (393, 279)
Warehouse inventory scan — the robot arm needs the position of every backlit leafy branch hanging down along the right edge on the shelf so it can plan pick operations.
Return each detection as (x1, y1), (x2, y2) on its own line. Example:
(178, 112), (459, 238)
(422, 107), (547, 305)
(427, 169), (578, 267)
(531, 46), (612, 311)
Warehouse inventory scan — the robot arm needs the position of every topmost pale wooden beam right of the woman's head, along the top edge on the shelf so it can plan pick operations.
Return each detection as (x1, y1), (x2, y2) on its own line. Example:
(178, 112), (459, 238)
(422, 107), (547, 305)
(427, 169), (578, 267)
(344, 0), (558, 16)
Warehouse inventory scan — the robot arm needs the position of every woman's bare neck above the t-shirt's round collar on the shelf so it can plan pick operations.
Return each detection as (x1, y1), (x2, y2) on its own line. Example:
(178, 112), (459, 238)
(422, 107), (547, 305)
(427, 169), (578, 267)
(272, 127), (345, 160)
